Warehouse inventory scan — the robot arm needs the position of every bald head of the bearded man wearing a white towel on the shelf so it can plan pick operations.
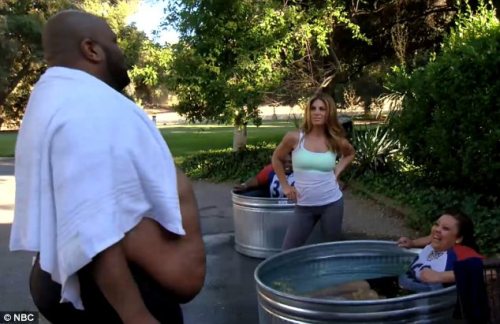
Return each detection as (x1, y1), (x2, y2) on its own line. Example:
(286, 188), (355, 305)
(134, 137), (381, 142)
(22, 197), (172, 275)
(42, 10), (130, 91)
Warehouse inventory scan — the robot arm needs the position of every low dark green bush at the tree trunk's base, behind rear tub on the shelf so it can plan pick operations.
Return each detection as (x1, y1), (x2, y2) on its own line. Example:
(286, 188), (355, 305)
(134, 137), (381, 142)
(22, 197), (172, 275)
(180, 143), (275, 181)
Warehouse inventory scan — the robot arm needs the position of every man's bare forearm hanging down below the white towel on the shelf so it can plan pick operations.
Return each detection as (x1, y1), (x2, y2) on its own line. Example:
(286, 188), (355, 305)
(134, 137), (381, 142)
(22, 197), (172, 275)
(90, 242), (159, 324)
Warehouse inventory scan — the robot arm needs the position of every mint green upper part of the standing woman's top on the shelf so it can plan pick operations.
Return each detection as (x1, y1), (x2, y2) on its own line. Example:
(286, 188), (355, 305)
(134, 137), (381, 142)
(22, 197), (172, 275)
(292, 132), (337, 172)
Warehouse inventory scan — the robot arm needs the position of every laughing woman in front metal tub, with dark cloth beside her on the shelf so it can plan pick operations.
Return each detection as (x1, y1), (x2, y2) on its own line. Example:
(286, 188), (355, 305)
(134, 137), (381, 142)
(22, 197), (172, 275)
(398, 211), (489, 323)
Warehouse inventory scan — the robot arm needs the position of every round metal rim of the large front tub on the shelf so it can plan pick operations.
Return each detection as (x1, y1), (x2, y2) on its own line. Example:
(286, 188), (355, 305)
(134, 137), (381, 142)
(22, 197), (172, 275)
(254, 240), (456, 306)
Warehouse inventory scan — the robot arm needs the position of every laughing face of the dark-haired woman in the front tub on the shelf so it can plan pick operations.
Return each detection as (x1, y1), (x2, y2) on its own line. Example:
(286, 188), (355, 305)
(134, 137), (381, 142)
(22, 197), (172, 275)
(431, 214), (462, 251)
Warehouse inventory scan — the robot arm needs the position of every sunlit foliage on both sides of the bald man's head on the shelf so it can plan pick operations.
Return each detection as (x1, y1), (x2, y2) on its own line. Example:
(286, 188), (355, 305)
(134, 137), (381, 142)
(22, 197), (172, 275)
(0, 0), (171, 124)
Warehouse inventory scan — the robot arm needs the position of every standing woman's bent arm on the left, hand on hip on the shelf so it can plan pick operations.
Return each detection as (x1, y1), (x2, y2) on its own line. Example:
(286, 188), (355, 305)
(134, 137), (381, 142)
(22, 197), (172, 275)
(272, 131), (299, 200)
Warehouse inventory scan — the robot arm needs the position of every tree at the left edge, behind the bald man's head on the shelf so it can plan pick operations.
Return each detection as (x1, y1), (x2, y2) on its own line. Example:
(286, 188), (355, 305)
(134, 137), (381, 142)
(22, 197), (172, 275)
(0, 0), (145, 124)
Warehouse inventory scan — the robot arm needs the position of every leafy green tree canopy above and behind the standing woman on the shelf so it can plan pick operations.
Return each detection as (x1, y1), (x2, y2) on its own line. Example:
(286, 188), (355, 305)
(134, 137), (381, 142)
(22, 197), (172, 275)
(167, 0), (478, 128)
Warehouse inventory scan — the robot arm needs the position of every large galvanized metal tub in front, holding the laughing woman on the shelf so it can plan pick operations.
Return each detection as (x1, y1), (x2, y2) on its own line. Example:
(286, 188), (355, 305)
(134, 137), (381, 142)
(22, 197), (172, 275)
(255, 241), (456, 324)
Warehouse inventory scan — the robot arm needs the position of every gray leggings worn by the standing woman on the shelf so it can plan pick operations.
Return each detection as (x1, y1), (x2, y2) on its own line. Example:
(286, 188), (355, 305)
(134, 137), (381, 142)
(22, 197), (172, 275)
(282, 198), (344, 250)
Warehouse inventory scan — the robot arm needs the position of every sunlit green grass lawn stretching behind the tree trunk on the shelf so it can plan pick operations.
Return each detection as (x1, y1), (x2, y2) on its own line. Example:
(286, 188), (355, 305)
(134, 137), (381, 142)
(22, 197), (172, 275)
(0, 121), (294, 162)
